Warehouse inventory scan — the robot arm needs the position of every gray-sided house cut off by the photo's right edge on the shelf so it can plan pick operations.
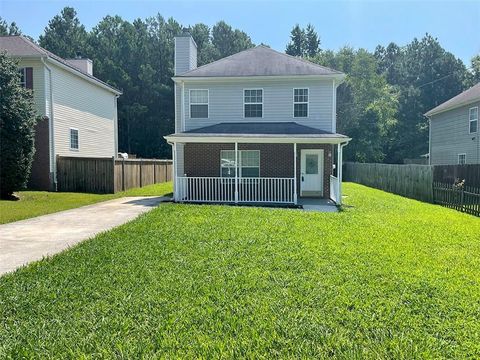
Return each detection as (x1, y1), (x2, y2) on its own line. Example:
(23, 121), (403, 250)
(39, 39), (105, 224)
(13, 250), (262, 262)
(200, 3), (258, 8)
(425, 83), (480, 165)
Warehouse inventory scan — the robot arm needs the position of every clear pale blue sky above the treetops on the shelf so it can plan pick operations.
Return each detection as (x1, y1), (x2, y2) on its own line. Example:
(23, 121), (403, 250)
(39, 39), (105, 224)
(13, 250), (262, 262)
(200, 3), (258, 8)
(0, 0), (480, 66)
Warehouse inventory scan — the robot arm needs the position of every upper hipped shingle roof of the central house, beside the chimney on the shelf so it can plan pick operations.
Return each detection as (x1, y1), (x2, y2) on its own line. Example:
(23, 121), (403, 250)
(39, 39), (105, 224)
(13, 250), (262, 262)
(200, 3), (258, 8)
(178, 45), (342, 77)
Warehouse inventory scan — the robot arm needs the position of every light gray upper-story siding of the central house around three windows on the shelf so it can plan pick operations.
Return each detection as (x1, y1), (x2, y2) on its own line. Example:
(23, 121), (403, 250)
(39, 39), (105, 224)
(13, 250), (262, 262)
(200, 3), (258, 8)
(177, 79), (335, 131)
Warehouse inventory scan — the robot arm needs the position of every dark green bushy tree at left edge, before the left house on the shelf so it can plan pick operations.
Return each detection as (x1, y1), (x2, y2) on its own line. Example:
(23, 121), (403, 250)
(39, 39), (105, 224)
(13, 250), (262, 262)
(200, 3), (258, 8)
(0, 53), (37, 200)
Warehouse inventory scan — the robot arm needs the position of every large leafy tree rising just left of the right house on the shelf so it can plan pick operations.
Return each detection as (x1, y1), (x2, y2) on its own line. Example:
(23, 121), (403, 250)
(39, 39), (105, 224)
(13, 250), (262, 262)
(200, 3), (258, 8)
(375, 34), (468, 162)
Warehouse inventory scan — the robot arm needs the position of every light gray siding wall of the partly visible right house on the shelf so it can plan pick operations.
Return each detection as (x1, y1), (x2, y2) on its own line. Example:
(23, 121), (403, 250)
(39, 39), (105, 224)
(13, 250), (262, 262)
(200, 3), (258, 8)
(430, 102), (480, 165)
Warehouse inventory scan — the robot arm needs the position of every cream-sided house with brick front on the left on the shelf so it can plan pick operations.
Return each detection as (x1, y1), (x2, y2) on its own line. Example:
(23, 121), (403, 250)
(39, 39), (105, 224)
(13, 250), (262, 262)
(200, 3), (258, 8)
(0, 36), (121, 190)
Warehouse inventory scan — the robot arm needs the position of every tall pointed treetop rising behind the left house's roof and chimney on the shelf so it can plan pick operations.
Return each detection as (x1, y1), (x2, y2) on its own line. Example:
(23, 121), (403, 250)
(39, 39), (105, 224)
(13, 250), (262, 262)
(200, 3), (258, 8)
(39, 7), (87, 58)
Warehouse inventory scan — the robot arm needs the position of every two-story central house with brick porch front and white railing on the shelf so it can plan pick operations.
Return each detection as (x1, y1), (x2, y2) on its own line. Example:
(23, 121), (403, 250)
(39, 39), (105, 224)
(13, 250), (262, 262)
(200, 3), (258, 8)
(165, 35), (350, 204)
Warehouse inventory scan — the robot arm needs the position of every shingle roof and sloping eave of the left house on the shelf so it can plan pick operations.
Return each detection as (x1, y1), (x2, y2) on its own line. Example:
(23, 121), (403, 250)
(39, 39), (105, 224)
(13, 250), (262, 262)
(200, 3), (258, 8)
(0, 35), (121, 93)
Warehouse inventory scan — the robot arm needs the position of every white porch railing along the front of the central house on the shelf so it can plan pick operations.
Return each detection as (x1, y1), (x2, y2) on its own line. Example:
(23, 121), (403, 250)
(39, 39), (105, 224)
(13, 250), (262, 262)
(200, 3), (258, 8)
(176, 176), (295, 204)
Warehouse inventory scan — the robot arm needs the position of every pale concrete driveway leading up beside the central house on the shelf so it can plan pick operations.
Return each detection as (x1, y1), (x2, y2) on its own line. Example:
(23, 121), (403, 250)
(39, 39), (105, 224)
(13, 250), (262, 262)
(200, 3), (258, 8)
(0, 197), (169, 275)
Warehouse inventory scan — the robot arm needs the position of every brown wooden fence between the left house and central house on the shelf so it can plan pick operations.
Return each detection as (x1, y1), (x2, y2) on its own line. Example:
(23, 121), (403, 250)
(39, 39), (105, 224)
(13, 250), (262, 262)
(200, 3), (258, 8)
(57, 156), (173, 194)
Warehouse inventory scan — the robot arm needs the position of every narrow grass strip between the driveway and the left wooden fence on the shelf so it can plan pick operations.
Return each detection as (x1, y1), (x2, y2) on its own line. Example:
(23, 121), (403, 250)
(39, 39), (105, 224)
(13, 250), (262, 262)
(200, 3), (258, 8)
(0, 182), (172, 224)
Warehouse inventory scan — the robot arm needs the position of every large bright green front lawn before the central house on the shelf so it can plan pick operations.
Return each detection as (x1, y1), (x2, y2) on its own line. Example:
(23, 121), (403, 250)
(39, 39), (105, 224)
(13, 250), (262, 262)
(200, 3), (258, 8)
(0, 184), (480, 359)
